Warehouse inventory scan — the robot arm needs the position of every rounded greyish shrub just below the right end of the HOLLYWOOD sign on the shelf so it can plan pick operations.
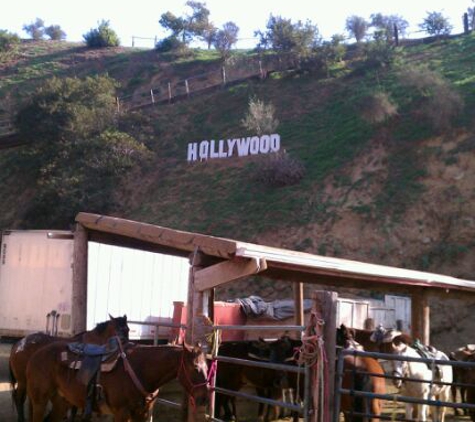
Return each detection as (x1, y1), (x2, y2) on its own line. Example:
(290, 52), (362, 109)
(254, 151), (305, 188)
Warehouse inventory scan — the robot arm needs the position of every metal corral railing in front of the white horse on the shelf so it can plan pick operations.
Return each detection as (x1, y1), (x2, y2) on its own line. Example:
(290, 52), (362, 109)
(333, 349), (475, 422)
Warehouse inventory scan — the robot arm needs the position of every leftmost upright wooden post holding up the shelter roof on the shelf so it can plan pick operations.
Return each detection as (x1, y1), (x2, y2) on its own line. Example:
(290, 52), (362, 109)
(71, 224), (87, 335)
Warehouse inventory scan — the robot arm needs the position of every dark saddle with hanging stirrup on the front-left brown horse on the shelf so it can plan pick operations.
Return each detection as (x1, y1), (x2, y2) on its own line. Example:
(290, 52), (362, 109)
(61, 337), (121, 416)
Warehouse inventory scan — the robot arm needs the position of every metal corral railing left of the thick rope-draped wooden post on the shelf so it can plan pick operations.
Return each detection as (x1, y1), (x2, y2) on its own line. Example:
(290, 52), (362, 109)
(207, 325), (310, 422)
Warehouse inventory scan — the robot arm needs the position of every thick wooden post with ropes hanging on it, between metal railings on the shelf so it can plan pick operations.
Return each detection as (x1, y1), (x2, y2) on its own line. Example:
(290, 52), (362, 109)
(307, 290), (338, 422)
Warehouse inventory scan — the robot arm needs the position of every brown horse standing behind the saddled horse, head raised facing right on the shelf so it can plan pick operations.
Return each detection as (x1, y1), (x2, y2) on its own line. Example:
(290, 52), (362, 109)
(9, 315), (129, 422)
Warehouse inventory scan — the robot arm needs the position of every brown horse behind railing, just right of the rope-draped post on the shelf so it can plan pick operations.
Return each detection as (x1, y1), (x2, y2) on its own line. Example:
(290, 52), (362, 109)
(336, 325), (386, 422)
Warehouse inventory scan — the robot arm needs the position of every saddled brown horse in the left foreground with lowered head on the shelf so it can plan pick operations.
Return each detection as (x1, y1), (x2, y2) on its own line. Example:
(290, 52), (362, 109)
(26, 341), (208, 422)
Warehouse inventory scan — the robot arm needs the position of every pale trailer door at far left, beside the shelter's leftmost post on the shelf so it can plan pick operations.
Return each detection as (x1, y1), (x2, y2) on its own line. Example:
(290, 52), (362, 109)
(0, 230), (74, 337)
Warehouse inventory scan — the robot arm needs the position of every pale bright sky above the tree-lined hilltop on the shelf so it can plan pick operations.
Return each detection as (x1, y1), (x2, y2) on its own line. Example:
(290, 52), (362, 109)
(0, 0), (474, 47)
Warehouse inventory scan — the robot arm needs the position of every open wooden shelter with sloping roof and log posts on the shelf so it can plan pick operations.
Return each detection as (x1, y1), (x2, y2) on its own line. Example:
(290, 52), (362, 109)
(73, 213), (475, 420)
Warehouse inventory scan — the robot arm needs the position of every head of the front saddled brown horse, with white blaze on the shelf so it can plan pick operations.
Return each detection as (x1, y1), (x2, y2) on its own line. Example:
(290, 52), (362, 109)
(178, 344), (209, 406)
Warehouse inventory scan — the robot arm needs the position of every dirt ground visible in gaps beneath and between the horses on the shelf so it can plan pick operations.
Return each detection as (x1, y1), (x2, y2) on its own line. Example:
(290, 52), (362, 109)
(0, 340), (470, 422)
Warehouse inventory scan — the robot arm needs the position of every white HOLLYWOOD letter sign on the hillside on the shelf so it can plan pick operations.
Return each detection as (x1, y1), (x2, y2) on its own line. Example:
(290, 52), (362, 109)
(187, 133), (280, 162)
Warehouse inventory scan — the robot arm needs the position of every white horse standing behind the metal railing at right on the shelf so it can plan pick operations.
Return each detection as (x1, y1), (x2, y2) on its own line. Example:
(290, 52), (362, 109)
(393, 343), (453, 422)
